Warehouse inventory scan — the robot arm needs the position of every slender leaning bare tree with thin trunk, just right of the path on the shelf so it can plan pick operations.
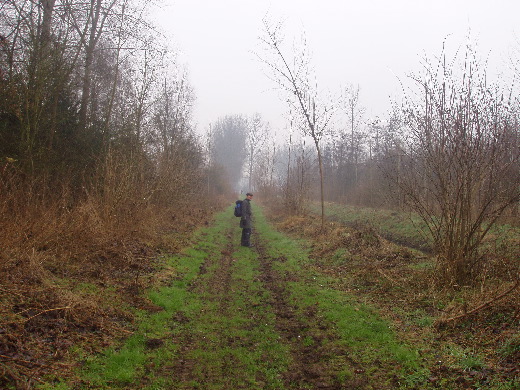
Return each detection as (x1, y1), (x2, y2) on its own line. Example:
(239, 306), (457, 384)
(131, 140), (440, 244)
(259, 19), (334, 227)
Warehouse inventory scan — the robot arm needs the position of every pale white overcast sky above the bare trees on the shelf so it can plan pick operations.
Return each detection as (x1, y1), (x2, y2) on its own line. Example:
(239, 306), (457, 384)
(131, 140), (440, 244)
(149, 0), (520, 132)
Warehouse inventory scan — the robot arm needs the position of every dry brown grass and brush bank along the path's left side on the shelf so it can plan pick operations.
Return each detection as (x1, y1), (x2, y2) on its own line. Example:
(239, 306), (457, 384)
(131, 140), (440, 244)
(0, 166), (218, 389)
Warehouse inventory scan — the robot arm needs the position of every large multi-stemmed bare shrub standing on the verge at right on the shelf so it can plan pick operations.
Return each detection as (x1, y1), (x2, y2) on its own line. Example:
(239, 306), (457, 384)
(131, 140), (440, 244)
(394, 48), (520, 286)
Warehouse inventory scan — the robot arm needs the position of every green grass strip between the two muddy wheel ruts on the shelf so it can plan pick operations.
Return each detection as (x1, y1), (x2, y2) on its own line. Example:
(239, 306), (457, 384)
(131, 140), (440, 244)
(175, 244), (287, 389)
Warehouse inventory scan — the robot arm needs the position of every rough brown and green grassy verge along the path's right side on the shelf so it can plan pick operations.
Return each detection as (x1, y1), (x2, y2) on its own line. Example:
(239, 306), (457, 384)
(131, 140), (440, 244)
(279, 205), (520, 390)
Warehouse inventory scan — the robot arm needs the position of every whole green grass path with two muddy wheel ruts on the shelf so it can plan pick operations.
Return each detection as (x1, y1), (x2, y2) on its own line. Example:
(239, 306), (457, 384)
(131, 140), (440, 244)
(61, 205), (428, 390)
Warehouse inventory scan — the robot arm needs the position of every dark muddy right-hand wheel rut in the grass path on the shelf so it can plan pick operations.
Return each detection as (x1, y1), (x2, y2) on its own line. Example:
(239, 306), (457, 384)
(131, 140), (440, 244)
(258, 245), (369, 390)
